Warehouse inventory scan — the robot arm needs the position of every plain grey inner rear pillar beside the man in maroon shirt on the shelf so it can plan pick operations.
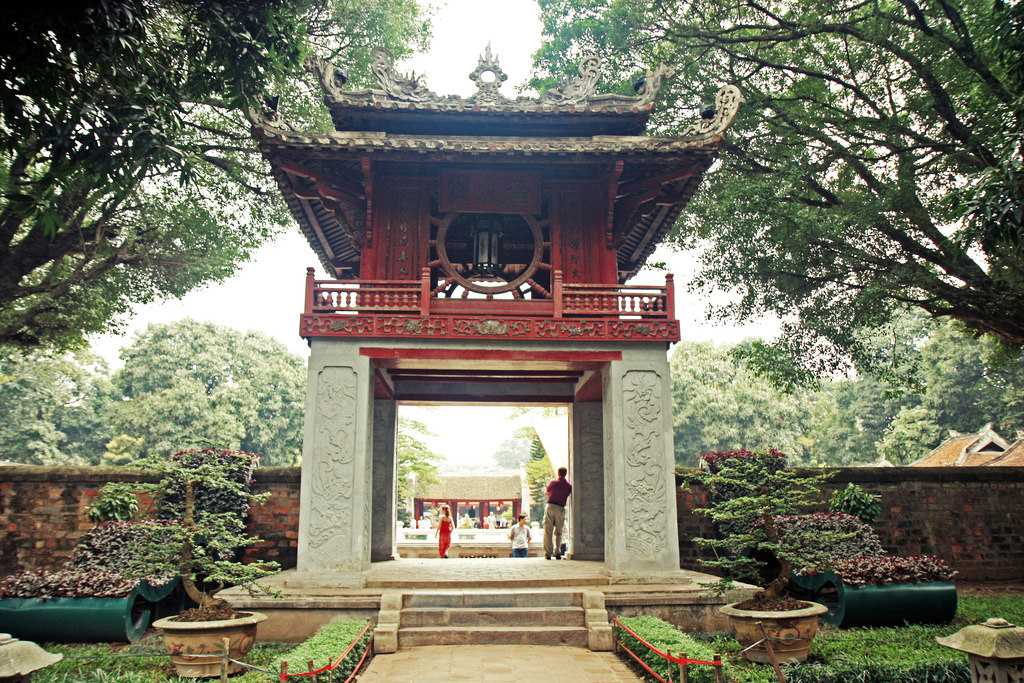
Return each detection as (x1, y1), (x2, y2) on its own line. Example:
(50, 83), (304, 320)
(569, 401), (604, 560)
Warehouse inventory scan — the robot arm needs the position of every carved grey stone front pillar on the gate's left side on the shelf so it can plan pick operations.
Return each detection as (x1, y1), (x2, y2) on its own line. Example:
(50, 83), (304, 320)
(298, 339), (373, 582)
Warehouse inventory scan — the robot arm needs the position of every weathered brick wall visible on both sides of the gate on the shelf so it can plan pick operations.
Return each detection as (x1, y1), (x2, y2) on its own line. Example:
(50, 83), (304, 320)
(0, 466), (1024, 581)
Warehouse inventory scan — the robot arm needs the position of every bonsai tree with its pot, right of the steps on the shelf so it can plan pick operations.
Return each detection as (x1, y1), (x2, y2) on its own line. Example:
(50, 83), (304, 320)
(693, 450), (842, 663)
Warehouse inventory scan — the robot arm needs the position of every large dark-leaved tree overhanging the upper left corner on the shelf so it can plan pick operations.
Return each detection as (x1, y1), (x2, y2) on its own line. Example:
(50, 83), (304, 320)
(0, 0), (426, 347)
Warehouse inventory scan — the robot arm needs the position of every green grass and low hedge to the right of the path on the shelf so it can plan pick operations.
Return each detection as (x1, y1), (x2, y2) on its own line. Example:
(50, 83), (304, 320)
(623, 595), (1024, 683)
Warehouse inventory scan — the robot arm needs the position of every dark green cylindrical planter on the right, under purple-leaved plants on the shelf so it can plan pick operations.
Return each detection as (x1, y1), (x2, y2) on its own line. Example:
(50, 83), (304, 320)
(790, 571), (956, 627)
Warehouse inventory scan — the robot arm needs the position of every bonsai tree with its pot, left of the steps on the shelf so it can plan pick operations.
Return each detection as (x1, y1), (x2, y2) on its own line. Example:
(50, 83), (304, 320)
(143, 449), (279, 678)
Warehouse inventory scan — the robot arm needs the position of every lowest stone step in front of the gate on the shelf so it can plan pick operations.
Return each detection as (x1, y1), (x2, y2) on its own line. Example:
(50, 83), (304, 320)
(398, 626), (587, 648)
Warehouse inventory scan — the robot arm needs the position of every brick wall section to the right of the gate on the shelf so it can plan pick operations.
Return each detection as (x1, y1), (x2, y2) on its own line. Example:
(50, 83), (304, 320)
(677, 467), (1024, 581)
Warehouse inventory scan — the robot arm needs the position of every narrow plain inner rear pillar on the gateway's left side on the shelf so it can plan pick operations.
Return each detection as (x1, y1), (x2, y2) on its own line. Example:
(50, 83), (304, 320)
(370, 398), (395, 562)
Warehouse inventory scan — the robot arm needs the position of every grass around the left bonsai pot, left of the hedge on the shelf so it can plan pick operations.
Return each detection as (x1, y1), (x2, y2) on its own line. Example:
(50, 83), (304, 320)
(32, 634), (294, 683)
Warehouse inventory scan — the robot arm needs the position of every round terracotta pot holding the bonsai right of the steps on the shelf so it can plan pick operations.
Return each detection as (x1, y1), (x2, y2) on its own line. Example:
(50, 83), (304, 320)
(719, 601), (828, 664)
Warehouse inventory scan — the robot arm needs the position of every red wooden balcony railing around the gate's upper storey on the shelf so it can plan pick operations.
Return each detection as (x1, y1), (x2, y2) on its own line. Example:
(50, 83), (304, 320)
(305, 268), (676, 321)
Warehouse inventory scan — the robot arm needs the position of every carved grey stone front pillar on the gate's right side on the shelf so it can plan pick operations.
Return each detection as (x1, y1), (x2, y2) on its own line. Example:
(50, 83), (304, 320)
(602, 346), (679, 573)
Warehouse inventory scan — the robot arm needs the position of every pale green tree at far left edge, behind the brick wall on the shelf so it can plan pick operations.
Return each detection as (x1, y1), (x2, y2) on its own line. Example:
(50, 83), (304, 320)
(0, 351), (110, 465)
